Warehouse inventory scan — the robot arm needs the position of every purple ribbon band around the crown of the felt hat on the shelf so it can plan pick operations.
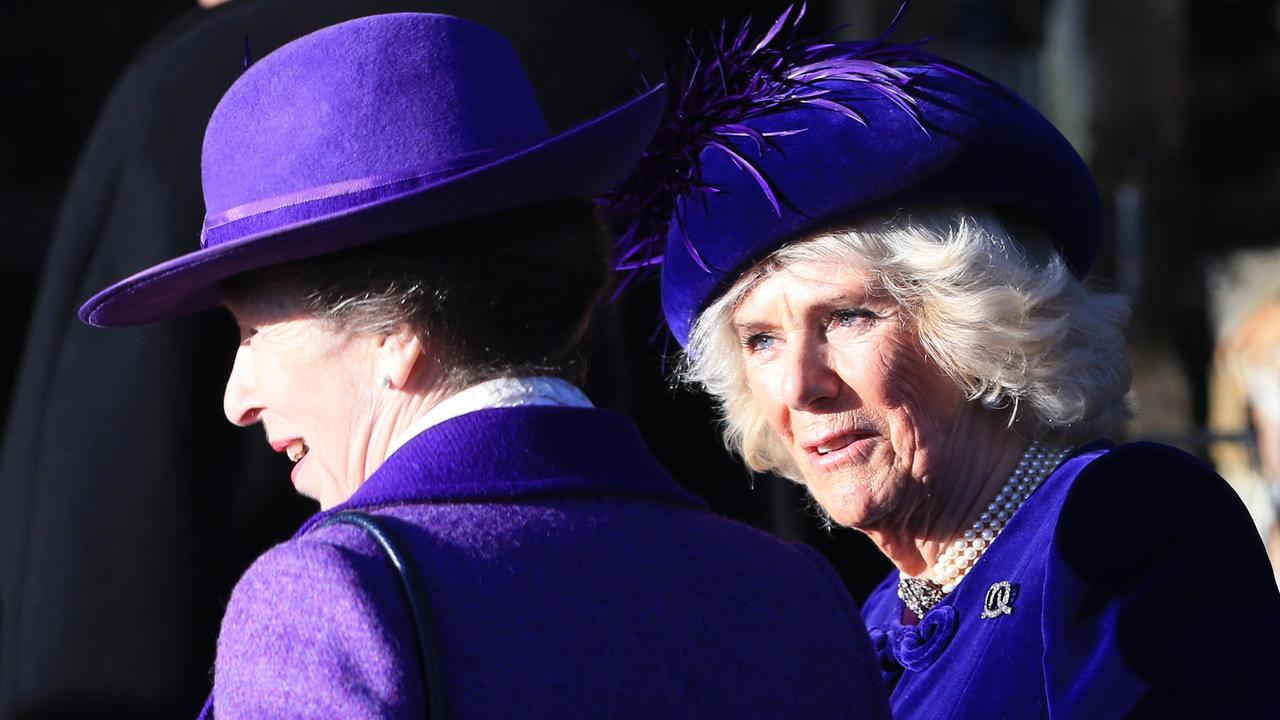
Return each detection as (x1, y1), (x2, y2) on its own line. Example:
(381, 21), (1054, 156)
(200, 147), (503, 250)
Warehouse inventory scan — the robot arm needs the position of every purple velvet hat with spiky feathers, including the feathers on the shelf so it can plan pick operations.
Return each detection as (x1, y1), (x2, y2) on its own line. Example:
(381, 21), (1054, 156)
(605, 5), (1102, 345)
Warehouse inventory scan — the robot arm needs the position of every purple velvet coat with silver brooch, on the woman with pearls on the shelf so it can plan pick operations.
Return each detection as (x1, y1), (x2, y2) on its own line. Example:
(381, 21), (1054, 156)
(864, 442), (1280, 720)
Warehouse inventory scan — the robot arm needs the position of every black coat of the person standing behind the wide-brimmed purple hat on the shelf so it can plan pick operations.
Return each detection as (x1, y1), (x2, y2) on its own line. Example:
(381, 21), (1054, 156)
(0, 0), (670, 720)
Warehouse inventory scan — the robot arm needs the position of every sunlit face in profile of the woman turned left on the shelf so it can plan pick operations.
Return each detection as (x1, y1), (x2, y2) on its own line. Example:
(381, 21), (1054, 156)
(223, 288), (378, 509)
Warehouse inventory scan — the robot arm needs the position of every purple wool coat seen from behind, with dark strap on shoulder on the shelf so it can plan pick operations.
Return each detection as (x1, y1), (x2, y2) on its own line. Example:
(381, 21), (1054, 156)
(197, 407), (888, 720)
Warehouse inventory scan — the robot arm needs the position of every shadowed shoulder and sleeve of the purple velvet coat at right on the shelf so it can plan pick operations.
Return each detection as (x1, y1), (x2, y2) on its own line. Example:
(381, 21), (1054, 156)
(1042, 442), (1280, 717)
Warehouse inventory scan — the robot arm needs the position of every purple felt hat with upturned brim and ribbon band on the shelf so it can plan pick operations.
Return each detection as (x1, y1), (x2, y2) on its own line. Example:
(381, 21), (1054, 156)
(79, 13), (664, 327)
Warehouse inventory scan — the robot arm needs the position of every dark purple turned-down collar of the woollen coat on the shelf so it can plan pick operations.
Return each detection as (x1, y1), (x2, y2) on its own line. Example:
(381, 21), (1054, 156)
(294, 406), (705, 537)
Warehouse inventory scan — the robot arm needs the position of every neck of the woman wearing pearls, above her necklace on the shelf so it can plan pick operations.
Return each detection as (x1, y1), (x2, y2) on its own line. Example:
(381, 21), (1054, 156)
(860, 414), (1029, 578)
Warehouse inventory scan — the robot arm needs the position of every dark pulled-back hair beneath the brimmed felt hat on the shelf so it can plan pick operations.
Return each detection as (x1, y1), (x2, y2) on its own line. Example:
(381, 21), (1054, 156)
(223, 200), (611, 387)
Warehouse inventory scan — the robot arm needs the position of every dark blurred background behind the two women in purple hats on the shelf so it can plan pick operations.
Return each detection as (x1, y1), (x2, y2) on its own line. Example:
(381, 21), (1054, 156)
(0, 0), (1280, 720)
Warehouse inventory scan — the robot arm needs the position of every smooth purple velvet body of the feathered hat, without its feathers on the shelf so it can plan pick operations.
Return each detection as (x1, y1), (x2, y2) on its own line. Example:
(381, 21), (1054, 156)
(662, 68), (1102, 345)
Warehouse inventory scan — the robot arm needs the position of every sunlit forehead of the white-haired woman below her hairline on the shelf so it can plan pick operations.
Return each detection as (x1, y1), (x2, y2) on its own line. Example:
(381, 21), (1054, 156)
(733, 260), (873, 315)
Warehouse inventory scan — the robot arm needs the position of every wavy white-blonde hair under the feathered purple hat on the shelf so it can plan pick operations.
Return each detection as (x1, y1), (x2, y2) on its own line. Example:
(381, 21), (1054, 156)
(678, 208), (1130, 479)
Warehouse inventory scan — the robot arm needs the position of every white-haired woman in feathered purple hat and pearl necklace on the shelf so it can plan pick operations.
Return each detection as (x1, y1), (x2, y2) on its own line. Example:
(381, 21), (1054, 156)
(611, 7), (1280, 720)
